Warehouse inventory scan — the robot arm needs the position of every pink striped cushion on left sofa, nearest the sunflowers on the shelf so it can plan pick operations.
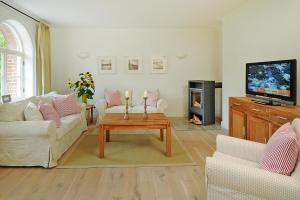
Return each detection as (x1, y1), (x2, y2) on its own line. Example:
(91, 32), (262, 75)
(53, 93), (80, 117)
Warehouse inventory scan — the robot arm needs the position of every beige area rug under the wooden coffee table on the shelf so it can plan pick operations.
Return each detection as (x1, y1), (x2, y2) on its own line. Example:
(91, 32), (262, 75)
(57, 130), (196, 168)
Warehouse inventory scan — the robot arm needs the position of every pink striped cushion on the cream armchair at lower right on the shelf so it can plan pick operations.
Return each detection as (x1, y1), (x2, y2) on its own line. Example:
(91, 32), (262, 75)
(260, 123), (299, 176)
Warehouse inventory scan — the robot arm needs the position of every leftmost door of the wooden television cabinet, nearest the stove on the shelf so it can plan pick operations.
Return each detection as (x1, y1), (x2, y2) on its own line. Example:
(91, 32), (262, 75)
(230, 109), (246, 139)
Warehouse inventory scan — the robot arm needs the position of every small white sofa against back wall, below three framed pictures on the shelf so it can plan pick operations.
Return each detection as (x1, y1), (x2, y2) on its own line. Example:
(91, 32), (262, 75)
(95, 89), (168, 124)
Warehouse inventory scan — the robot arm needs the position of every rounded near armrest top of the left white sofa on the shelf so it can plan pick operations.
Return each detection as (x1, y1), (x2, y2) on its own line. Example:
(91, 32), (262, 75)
(0, 121), (56, 139)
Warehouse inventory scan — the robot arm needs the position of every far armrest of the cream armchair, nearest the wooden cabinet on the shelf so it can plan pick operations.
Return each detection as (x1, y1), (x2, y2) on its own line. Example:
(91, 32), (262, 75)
(216, 135), (266, 163)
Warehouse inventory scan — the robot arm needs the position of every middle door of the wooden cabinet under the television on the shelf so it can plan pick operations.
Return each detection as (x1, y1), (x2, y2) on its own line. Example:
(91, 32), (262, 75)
(247, 115), (269, 143)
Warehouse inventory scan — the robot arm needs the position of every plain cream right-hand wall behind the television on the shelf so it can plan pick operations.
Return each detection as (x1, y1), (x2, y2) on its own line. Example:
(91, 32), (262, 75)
(222, 0), (300, 128)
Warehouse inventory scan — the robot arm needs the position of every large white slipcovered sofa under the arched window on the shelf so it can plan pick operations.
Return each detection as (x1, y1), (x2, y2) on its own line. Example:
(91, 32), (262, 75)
(0, 95), (87, 168)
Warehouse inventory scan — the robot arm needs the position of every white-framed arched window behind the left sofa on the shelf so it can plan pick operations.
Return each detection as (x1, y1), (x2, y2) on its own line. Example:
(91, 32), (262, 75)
(0, 20), (33, 100)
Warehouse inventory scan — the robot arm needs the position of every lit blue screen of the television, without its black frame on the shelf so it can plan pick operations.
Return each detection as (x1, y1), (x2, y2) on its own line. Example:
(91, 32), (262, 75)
(247, 62), (292, 97)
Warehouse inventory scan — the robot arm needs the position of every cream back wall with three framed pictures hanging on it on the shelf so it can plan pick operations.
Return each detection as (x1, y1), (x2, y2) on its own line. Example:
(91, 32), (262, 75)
(51, 28), (221, 116)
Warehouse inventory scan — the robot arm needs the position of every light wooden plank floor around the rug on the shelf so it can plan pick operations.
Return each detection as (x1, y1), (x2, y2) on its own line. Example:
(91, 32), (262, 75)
(0, 118), (220, 200)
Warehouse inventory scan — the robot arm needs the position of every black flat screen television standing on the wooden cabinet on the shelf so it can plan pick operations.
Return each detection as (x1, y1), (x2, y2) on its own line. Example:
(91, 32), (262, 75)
(246, 59), (297, 105)
